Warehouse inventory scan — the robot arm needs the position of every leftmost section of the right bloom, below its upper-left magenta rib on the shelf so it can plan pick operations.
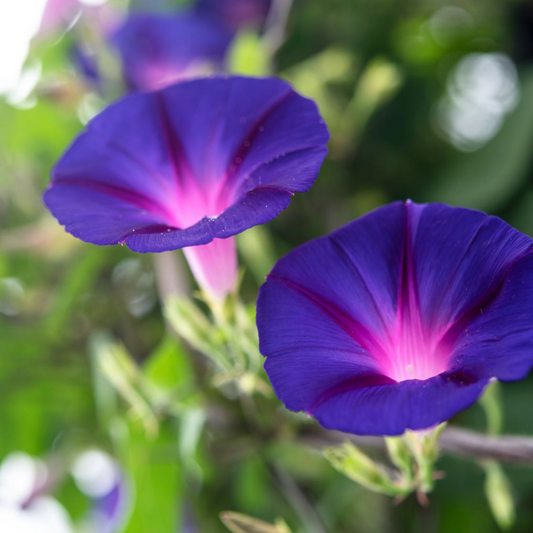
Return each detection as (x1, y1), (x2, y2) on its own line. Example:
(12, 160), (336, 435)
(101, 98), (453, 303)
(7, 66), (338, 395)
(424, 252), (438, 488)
(257, 278), (386, 411)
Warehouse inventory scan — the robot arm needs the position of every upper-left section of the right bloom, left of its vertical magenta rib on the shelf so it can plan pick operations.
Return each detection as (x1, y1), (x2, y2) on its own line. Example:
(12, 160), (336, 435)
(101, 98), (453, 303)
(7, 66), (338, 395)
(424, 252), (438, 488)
(258, 202), (406, 354)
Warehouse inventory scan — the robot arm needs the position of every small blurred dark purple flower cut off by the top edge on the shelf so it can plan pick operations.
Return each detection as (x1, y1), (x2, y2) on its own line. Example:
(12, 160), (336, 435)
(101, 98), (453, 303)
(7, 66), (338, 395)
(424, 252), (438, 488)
(196, 0), (272, 30)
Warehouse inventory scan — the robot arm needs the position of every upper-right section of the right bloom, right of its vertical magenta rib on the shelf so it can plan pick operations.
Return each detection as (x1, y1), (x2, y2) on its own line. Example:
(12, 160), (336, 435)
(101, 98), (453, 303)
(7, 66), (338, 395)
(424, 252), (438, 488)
(413, 204), (531, 331)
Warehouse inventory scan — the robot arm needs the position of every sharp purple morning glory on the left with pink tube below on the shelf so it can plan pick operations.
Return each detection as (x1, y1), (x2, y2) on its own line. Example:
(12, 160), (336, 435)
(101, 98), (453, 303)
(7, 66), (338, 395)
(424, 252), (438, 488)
(44, 77), (329, 295)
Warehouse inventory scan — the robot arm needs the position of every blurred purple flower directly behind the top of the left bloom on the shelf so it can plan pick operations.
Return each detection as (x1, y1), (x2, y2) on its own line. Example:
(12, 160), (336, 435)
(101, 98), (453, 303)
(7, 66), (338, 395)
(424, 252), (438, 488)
(112, 12), (231, 90)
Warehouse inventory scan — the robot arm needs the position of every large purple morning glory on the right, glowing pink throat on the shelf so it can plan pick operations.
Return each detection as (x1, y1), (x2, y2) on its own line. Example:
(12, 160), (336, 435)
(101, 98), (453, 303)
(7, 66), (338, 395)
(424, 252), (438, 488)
(257, 202), (533, 435)
